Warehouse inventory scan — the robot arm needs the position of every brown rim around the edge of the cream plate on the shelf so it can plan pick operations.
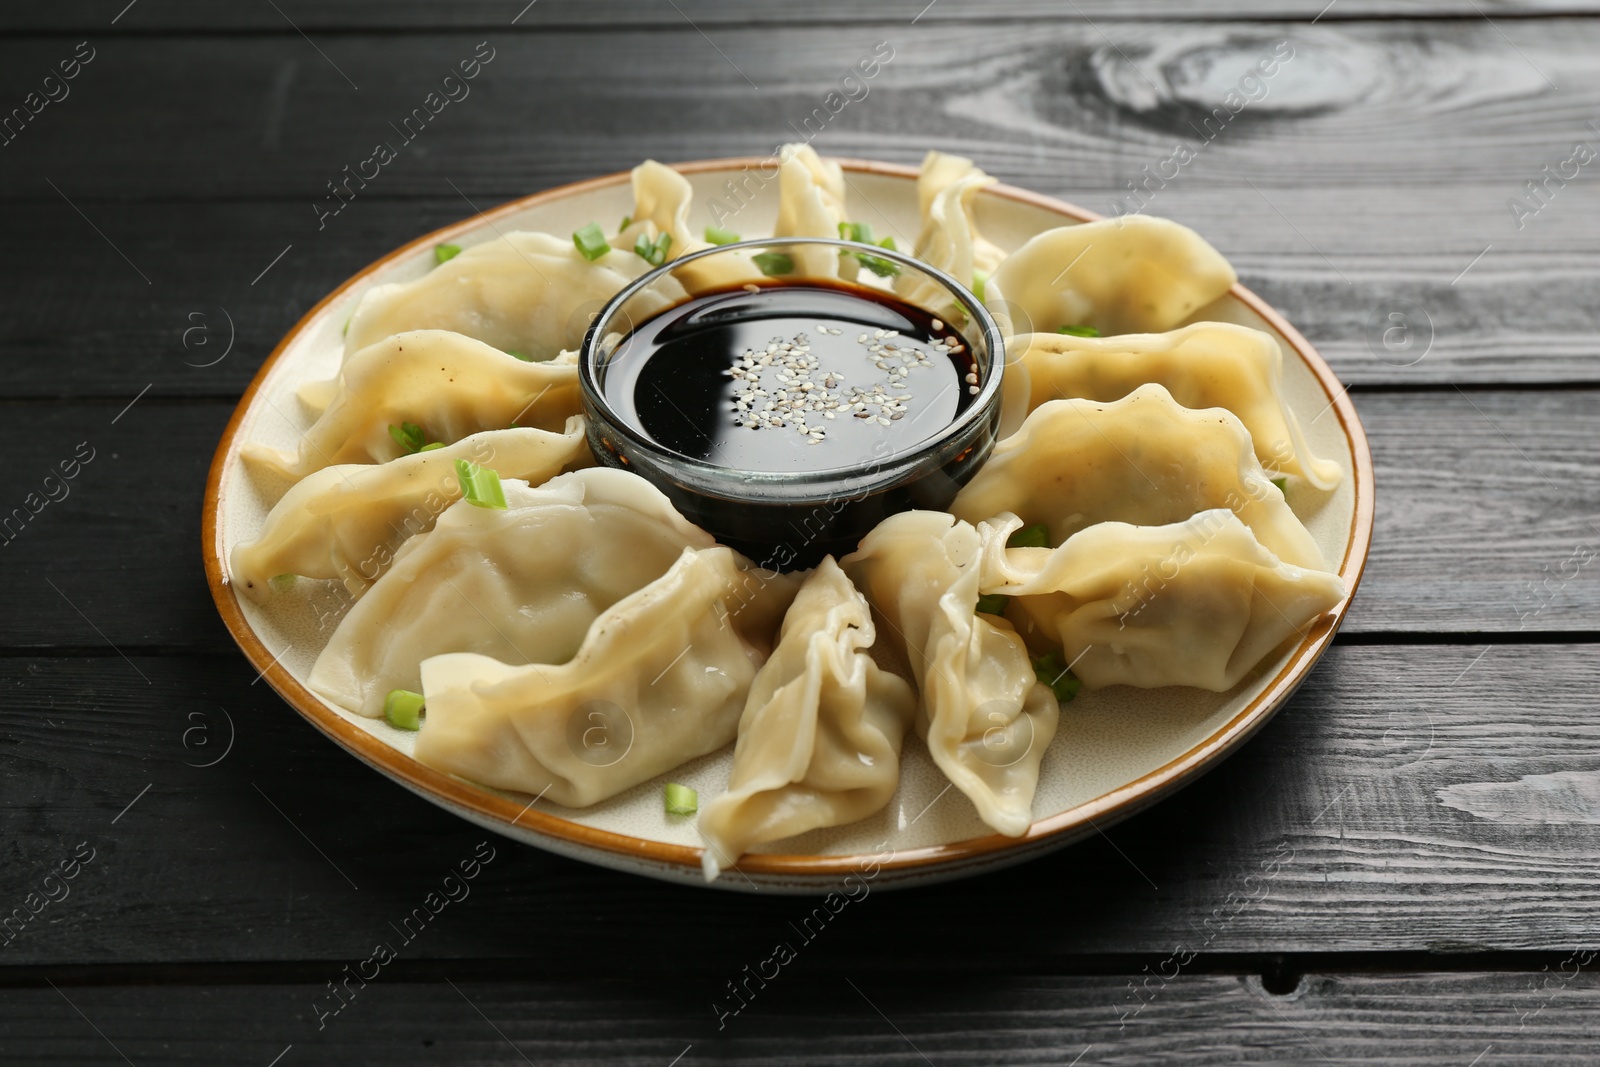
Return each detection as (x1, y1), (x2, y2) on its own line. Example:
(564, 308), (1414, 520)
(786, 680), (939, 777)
(200, 155), (1374, 883)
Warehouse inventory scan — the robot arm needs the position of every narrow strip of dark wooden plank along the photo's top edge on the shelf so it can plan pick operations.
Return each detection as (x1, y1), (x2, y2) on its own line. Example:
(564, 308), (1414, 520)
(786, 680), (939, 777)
(0, 0), (1597, 35)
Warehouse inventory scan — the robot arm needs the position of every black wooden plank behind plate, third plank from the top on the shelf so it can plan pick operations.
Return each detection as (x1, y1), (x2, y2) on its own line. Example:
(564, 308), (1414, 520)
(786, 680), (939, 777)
(0, 185), (1600, 403)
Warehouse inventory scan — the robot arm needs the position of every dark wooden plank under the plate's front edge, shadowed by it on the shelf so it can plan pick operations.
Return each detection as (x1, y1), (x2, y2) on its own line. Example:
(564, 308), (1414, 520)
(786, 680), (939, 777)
(0, 645), (1600, 966)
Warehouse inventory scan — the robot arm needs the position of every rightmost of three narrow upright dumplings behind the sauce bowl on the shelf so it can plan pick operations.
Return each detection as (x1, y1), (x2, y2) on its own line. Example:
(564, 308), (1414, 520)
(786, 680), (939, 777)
(894, 152), (1005, 310)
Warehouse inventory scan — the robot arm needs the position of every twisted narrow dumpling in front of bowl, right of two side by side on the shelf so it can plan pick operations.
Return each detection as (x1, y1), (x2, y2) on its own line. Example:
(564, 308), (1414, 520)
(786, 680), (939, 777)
(840, 512), (1061, 837)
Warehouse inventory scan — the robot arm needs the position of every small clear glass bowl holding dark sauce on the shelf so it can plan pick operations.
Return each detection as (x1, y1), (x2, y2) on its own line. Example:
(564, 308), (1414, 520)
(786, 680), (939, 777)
(579, 237), (1005, 571)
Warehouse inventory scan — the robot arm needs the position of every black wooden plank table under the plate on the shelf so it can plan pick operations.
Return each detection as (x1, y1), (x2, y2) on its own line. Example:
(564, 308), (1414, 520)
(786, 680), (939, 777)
(0, 0), (1600, 1067)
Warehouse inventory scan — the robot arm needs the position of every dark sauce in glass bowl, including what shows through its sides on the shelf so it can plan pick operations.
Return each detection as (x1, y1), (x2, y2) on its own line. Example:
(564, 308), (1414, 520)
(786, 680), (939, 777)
(586, 278), (1000, 569)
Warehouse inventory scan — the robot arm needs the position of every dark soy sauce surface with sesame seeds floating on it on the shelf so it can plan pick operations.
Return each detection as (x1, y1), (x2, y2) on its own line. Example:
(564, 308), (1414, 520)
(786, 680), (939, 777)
(603, 280), (979, 472)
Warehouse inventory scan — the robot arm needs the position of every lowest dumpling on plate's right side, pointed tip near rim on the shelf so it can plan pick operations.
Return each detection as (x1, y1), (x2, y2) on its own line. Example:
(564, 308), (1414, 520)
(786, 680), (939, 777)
(982, 509), (1344, 693)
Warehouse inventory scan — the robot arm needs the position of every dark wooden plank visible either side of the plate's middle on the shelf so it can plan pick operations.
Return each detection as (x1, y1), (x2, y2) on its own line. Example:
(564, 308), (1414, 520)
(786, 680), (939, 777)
(0, 389), (1600, 651)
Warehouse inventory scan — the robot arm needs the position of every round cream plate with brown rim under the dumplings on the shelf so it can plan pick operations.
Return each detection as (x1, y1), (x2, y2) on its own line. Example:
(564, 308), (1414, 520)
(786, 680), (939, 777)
(202, 157), (1373, 893)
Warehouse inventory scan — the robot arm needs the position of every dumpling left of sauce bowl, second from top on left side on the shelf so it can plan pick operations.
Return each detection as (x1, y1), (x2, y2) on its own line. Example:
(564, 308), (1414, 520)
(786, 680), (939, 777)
(242, 329), (582, 478)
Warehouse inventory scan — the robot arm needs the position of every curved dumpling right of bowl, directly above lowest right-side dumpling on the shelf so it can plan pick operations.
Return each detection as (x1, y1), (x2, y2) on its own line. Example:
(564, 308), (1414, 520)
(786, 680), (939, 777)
(950, 384), (1328, 571)
